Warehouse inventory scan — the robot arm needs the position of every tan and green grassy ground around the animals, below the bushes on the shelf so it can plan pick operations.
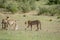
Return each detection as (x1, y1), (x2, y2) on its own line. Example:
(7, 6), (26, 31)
(0, 14), (60, 40)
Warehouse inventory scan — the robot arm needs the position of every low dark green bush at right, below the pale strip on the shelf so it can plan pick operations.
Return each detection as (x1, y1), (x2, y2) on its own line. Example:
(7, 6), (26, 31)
(37, 5), (60, 16)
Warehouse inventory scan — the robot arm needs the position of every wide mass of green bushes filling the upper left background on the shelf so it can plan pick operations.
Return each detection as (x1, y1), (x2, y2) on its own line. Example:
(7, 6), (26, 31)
(0, 0), (36, 12)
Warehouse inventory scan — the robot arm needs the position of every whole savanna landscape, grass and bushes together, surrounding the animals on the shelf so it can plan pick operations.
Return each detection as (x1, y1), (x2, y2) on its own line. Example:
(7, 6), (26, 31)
(0, 0), (60, 40)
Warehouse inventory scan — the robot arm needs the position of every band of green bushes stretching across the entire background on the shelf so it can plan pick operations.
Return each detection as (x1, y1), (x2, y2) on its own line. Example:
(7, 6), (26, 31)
(0, 0), (60, 16)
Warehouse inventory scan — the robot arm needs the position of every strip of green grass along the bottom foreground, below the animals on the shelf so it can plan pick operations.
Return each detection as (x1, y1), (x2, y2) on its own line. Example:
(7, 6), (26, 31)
(0, 31), (60, 40)
